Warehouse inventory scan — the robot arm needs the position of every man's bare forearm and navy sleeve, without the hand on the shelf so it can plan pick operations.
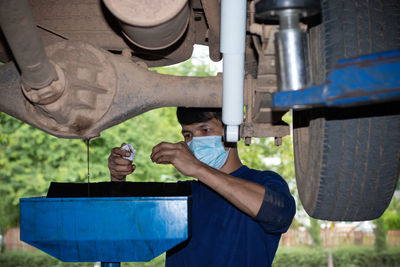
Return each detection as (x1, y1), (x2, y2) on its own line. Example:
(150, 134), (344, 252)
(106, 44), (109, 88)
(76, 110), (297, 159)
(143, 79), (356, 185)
(194, 164), (296, 233)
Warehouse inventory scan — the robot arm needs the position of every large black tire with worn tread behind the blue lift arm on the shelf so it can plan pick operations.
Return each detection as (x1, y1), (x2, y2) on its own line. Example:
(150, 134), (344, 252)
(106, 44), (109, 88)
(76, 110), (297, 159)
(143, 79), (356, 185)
(293, 0), (400, 221)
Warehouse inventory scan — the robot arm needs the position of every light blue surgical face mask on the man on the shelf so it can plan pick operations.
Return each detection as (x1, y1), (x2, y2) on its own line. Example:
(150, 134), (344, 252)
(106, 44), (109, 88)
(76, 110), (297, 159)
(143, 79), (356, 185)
(187, 135), (229, 169)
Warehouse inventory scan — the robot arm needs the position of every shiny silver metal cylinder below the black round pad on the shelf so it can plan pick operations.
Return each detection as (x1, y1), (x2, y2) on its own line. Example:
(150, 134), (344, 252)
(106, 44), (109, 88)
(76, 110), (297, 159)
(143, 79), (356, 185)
(275, 9), (310, 91)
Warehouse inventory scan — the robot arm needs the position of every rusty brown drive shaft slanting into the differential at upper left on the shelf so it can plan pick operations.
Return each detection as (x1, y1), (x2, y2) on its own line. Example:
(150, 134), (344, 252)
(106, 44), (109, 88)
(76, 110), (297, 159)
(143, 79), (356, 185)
(0, 0), (57, 91)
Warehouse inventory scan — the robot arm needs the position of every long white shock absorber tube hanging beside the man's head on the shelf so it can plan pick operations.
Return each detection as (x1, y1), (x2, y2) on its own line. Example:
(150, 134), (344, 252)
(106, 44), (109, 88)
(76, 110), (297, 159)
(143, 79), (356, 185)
(221, 0), (247, 142)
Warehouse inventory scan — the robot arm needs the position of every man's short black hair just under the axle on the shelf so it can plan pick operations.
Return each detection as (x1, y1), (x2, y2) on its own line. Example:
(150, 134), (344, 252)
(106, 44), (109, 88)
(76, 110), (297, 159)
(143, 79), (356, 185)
(176, 107), (222, 125)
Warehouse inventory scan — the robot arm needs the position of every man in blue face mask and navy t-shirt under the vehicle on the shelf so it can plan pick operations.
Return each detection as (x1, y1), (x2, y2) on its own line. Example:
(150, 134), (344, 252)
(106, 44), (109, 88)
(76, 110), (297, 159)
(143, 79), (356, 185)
(108, 108), (295, 267)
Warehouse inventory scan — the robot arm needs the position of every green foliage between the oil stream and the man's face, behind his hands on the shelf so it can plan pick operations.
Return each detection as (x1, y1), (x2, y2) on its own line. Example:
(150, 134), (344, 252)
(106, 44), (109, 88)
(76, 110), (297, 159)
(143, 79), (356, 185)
(91, 108), (184, 181)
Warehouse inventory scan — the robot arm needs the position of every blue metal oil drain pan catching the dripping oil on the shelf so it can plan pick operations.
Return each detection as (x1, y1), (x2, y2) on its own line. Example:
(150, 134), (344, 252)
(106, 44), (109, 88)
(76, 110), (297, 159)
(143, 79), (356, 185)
(20, 182), (191, 262)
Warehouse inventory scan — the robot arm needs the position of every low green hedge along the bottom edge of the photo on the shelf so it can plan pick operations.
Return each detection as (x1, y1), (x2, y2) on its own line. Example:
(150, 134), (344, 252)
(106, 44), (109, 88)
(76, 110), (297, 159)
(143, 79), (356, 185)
(0, 246), (400, 267)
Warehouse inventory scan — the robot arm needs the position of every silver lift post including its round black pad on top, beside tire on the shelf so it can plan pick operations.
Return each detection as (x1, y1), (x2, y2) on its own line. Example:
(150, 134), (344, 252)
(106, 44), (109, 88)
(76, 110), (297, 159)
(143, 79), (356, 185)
(256, 0), (321, 91)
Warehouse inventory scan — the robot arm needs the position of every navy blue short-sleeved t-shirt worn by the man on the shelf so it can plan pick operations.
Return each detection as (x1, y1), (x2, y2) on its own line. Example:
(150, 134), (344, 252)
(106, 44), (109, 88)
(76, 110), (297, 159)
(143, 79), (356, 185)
(165, 166), (295, 267)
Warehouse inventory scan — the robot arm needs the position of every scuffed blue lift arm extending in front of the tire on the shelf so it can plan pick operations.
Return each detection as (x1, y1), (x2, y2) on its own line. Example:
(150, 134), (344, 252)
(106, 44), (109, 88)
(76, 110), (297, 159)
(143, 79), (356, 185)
(272, 50), (400, 109)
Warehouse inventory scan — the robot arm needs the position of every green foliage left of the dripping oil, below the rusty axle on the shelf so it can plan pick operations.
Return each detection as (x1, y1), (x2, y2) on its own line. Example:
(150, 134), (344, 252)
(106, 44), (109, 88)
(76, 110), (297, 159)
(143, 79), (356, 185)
(0, 113), (84, 230)
